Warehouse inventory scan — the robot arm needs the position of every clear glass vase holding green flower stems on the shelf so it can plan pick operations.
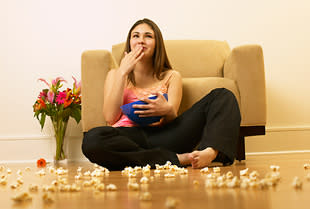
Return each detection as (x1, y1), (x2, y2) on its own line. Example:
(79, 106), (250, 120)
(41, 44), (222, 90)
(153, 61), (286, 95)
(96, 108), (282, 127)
(52, 119), (68, 162)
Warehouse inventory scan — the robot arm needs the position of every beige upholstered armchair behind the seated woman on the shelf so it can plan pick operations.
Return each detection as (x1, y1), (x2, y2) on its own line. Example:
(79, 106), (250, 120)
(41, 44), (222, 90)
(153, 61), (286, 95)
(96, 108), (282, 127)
(82, 40), (266, 160)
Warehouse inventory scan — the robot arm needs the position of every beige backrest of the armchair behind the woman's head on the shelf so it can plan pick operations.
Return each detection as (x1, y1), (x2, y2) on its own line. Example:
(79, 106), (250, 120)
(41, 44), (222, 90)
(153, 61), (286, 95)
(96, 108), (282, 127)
(112, 40), (230, 78)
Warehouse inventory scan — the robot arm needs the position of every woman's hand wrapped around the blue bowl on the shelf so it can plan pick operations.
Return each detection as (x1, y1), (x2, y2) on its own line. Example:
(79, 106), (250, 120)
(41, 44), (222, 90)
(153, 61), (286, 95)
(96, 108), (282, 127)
(132, 92), (172, 117)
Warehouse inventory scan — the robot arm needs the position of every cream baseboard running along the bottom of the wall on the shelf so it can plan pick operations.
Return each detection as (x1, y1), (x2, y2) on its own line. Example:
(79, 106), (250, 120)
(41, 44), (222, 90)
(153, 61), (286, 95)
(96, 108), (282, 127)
(0, 126), (310, 164)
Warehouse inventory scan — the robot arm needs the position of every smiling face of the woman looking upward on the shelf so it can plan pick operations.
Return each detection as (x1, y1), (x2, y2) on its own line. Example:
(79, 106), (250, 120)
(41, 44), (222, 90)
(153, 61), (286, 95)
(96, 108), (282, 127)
(130, 23), (155, 57)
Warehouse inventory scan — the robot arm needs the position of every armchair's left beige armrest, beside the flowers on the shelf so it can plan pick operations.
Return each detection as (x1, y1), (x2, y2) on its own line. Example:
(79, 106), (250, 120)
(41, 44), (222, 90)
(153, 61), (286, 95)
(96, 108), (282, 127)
(81, 50), (116, 132)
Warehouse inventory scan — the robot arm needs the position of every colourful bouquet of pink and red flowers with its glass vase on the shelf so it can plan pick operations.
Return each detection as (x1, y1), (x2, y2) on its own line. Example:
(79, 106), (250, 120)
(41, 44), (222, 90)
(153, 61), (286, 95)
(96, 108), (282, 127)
(33, 76), (81, 161)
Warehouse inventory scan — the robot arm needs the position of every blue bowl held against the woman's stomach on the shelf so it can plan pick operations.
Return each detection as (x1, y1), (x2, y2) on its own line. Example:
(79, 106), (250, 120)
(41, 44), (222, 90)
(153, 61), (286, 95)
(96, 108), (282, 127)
(121, 94), (168, 126)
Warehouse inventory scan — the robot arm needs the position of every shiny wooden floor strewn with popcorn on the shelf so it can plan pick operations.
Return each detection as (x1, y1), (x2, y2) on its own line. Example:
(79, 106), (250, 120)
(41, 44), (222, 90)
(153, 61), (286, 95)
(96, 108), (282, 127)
(0, 153), (310, 209)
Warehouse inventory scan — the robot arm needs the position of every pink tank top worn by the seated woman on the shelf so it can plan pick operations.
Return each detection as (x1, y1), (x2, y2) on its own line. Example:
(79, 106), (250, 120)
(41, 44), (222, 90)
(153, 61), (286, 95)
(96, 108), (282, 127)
(112, 73), (173, 127)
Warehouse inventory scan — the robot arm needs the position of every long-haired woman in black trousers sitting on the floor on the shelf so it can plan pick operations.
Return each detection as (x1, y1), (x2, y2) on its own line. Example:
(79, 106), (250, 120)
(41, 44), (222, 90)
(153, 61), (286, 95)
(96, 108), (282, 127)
(82, 19), (241, 170)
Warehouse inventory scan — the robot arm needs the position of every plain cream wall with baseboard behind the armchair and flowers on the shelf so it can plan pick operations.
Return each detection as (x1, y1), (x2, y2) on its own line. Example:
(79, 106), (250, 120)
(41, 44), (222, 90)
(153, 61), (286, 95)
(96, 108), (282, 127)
(0, 0), (310, 161)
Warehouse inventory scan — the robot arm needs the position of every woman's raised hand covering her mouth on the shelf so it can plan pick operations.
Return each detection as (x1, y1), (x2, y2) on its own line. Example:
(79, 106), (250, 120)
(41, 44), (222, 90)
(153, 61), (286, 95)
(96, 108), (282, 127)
(119, 45), (144, 75)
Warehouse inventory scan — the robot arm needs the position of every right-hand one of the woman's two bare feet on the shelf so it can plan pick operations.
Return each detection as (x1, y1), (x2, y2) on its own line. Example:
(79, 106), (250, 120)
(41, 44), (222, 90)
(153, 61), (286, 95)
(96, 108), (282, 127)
(189, 147), (218, 168)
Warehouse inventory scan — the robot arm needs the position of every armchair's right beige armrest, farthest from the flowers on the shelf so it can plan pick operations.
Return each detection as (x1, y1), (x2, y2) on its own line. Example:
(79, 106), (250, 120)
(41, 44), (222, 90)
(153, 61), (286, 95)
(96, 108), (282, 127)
(224, 45), (266, 126)
